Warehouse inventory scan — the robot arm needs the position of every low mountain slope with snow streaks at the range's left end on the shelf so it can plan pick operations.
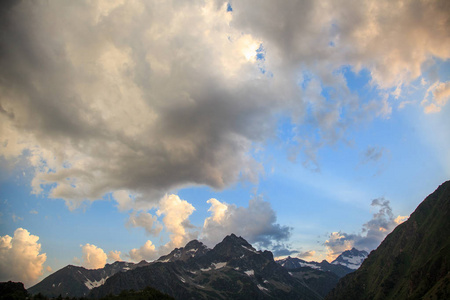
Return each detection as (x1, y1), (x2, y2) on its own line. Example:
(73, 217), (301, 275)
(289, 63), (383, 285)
(28, 261), (148, 297)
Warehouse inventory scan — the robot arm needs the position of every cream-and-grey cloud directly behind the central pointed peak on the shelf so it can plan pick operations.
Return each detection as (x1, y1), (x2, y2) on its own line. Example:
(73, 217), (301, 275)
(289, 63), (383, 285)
(202, 197), (291, 248)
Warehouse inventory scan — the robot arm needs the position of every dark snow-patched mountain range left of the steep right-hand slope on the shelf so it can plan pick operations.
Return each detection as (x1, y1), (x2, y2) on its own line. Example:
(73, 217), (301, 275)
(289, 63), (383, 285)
(28, 234), (362, 299)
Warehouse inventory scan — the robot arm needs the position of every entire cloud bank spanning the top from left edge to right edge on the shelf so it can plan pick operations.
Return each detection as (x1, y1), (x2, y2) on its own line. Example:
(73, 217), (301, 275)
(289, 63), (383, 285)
(0, 0), (450, 210)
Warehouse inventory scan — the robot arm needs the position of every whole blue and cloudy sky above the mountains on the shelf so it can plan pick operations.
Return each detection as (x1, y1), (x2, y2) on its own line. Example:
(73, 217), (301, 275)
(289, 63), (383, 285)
(0, 0), (450, 287)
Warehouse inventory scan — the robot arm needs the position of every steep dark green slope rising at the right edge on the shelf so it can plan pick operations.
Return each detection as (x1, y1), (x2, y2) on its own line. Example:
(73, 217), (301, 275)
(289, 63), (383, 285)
(326, 181), (450, 300)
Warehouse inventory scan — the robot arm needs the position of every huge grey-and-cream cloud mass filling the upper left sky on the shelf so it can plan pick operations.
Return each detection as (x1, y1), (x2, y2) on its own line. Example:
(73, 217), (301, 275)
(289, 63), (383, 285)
(0, 1), (275, 210)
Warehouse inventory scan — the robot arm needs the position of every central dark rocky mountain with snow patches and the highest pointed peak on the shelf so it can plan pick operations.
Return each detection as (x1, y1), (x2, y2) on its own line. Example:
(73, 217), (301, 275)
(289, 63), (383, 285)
(90, 234), (322, 299)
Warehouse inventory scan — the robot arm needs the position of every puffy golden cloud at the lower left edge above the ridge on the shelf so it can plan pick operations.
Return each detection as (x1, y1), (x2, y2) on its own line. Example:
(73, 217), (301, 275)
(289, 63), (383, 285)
(0, 228), (47, 287)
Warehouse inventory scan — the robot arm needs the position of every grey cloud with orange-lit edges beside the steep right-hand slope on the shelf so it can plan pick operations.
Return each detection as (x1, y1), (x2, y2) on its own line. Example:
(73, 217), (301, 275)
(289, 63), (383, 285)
(325, 198), (408, 261)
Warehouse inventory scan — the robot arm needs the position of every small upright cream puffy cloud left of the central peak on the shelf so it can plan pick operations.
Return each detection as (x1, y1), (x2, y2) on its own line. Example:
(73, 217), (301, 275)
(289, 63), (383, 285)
(156, 194), (196, 250)
